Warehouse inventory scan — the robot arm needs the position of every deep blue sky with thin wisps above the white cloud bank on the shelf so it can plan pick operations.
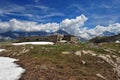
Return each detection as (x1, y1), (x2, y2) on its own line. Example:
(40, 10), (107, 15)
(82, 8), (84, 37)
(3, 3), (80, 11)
(0, 0), (120, 28)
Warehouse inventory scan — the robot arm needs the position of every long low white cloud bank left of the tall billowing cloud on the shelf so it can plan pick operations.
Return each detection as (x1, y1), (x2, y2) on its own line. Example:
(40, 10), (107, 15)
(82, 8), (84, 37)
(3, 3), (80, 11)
(0, 19), (59, 33)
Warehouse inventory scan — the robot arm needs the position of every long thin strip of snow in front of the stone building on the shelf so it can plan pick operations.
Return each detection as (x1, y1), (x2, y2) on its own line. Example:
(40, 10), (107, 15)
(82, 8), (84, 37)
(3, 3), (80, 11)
(13, 42), (54, 45)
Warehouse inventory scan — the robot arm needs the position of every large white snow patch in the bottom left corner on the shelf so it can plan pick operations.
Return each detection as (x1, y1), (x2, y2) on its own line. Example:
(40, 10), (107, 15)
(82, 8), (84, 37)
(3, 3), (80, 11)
(0, 57), (25, 80)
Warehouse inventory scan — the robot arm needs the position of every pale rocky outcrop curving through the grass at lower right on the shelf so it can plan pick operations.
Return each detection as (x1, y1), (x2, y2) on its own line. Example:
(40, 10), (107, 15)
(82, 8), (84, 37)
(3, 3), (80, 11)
(62, 50), (120, 80)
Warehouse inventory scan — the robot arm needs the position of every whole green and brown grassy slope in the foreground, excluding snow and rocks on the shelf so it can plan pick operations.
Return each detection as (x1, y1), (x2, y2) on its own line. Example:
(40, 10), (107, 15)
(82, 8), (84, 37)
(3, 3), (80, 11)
(2, 43), (120, 80)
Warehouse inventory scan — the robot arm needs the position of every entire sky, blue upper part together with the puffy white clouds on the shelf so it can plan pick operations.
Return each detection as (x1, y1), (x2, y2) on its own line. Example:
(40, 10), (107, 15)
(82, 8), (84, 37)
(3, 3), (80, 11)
(0, 0), (120, 37)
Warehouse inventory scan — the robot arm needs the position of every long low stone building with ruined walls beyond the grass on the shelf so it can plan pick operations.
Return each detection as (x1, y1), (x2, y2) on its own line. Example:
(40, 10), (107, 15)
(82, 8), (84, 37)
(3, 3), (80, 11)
(17, 34), (78, 43)
